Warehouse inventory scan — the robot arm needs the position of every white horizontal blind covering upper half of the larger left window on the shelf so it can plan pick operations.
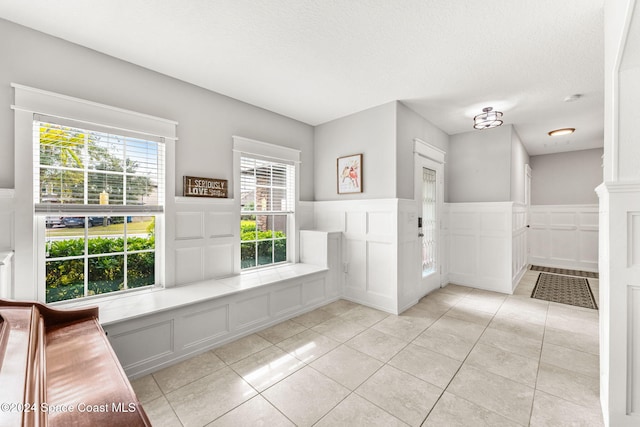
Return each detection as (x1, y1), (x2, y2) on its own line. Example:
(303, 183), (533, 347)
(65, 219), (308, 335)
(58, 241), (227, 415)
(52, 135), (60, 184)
(33, 115), (165, 215)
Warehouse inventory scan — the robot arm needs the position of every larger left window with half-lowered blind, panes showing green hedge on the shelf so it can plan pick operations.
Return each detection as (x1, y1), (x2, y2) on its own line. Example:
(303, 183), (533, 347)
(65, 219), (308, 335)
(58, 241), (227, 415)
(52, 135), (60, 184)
(34, 118), (164, 302)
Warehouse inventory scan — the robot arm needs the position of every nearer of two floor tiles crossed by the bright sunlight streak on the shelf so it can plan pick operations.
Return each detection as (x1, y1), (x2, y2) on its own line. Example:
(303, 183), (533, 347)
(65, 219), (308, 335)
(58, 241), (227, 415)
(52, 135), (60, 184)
(231, 346), (305, 391)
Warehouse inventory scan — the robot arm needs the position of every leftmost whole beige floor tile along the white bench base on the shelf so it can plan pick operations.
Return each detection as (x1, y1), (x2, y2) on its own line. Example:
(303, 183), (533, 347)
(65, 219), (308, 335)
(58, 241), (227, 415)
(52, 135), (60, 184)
(153, 351), (225, 393)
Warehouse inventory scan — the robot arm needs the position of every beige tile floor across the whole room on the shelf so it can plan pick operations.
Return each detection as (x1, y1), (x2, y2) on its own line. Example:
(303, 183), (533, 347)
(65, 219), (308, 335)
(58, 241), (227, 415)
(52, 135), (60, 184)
(133, 271), (603, 427)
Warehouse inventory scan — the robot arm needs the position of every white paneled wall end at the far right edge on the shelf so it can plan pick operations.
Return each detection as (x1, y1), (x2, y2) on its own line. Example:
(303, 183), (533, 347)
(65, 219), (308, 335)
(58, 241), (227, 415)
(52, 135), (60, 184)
(598, 0), (640, 427)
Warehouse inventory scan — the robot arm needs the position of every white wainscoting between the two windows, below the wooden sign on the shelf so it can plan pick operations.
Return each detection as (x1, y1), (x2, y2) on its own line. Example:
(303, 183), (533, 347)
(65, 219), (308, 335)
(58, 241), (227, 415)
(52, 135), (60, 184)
(172, 197), (240, 285)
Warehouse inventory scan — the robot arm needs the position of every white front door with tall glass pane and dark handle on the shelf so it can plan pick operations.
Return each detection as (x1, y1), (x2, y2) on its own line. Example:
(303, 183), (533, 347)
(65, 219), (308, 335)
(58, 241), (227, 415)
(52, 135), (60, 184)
(414, 155), (444, 295)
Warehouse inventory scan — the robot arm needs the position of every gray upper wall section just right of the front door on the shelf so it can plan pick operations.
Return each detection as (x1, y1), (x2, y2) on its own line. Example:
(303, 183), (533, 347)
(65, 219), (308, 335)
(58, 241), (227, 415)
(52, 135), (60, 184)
(446, 125), (512, 203)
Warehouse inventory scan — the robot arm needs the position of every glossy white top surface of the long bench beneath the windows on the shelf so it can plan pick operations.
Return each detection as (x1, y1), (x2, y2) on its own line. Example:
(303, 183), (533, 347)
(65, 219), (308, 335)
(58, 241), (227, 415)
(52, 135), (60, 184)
(55, 263), (328, 326)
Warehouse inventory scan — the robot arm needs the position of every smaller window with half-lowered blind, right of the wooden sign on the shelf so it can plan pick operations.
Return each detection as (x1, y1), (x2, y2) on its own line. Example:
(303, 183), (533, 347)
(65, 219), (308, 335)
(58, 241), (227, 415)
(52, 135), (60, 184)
(240, 155), (295, 269)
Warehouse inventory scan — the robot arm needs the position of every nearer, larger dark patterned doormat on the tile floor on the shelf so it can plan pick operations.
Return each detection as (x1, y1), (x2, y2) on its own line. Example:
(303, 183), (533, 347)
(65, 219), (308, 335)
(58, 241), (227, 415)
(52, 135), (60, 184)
(531, 273), (598, 310)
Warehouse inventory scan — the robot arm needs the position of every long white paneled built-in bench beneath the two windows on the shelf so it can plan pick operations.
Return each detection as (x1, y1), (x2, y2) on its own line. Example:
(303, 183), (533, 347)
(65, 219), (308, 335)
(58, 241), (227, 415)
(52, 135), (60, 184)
(56, 254), (340, 378)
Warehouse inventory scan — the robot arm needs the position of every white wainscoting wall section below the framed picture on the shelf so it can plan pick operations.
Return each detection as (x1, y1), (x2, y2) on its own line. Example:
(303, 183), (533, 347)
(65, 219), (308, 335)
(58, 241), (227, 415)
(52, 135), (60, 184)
(315, 199), (398, 313)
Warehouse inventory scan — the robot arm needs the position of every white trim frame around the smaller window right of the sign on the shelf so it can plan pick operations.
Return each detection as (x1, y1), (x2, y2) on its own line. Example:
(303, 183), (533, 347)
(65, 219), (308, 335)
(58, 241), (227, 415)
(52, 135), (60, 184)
(230, 135), (301, 274)
